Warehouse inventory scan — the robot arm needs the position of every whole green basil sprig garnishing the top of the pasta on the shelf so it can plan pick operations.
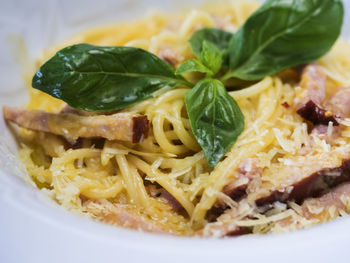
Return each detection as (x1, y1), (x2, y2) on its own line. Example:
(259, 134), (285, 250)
(32, 0), (344, 167)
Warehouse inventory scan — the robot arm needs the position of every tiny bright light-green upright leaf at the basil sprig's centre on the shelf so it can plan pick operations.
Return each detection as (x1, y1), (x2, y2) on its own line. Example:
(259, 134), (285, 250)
(201, 40), (222, 75)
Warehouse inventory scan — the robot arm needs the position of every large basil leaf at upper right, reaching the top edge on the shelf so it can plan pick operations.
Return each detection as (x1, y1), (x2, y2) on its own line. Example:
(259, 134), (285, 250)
(223, 0), (344, 80)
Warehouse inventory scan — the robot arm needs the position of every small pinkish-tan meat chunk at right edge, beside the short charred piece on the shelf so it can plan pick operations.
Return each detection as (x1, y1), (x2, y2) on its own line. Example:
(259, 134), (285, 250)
(326, 87), (350, 118)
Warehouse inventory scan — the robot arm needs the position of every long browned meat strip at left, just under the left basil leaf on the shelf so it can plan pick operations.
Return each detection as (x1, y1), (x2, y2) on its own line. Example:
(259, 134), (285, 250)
(3, 107), (149, 143)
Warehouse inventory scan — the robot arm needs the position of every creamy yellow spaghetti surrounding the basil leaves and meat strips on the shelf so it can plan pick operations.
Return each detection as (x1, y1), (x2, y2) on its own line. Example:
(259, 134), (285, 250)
(15, 1), (350, 235)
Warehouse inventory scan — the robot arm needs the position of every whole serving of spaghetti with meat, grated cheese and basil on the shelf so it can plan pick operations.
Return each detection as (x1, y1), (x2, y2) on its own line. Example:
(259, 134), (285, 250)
(3, 0), (350, 237)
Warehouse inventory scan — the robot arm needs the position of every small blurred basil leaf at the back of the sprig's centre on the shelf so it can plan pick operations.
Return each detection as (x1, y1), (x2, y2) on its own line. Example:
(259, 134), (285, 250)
(189, 28), (233, 58)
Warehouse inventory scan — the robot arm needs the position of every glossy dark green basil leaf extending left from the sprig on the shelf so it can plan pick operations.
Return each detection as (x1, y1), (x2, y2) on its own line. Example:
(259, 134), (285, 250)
(32, 44), (192, 111)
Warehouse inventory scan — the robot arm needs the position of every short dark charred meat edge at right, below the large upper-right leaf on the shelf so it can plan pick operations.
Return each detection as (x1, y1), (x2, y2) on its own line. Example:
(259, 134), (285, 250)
(297, 100), (339, 126)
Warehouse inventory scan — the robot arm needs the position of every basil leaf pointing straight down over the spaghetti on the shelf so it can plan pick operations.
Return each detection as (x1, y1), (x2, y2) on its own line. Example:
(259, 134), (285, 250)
(185, 78), (244, 167)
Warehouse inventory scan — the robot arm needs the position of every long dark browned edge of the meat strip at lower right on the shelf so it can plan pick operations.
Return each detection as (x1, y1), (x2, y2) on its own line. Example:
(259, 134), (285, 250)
(255, 160), (350, 206)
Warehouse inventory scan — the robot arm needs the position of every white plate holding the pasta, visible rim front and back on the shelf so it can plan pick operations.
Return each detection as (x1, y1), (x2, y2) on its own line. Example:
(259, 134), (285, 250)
(0, 0), (350, 263)
